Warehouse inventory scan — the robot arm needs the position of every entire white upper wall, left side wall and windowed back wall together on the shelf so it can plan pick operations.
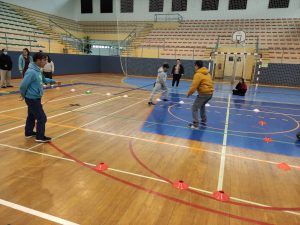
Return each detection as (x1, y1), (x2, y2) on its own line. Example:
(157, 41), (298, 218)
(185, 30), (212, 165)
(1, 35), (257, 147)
(3, 0), (300, 21)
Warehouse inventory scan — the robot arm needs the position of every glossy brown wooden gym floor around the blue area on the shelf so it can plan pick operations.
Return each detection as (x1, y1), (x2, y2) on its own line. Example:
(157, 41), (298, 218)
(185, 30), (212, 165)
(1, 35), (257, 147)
(0, 74), (300, 225)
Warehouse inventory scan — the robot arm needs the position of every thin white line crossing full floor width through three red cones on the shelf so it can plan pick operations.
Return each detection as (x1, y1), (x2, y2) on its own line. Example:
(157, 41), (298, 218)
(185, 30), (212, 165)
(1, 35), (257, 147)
(0, 144), (300, 216)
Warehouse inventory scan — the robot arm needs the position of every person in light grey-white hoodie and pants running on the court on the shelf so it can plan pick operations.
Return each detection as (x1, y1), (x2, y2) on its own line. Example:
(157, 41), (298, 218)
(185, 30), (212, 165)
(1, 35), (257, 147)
(148, 63), (169, 106)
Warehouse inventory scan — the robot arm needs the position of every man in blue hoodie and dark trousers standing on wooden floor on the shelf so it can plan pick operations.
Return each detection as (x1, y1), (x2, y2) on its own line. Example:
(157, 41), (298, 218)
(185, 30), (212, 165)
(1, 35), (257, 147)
(20, 52), (56, 143)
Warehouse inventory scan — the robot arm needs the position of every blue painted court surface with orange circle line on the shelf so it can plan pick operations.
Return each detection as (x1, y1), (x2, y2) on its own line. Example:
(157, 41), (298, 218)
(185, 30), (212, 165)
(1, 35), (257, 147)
(124, 78), (300, 157)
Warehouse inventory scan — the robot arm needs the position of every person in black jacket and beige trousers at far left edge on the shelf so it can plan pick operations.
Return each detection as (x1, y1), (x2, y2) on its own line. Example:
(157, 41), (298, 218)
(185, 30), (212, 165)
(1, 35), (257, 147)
(0, 48), (12, 88)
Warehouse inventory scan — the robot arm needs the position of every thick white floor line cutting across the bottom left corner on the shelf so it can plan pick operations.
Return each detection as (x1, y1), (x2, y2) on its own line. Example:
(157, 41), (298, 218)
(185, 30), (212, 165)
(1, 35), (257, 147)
(0, 199), (79, 225)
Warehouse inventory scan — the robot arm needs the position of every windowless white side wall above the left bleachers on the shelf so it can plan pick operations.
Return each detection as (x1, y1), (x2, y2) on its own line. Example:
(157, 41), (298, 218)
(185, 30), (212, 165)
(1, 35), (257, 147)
(1, 0), (76, 19)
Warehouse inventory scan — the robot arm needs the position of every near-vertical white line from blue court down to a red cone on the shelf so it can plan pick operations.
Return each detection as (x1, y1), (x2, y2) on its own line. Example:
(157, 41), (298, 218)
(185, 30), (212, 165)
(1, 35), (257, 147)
(217, 95), (230, 191)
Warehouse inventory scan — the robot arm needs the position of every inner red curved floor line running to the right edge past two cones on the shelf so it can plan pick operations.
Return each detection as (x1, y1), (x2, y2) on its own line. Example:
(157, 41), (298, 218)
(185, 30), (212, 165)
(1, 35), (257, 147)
(129, 140), (300, 211)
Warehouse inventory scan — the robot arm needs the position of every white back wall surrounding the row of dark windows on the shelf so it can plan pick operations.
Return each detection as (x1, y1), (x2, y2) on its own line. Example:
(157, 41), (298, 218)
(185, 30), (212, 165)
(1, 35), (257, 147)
(76, 0), (300, 21)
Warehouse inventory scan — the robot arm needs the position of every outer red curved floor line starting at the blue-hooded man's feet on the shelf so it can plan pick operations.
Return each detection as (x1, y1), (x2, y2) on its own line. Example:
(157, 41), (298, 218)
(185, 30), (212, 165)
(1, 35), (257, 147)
(49, 143), (274, 225)
